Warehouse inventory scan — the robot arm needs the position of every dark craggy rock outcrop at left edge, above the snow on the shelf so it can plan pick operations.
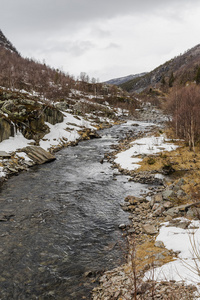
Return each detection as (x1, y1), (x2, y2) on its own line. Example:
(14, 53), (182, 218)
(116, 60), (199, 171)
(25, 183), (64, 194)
(0, 89), (63, 144)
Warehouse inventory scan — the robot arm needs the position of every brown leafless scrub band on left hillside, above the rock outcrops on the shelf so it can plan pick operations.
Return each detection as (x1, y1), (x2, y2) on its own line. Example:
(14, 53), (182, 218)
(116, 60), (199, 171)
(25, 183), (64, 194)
(0, 46), (136, 113)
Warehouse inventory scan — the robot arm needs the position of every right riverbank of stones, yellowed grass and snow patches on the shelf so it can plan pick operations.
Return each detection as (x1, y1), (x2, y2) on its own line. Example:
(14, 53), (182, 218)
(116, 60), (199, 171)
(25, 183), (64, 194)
(92, 109), (200, 300)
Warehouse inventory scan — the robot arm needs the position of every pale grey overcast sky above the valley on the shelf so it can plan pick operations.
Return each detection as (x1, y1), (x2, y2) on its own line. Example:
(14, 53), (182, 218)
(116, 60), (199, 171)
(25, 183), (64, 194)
(0, 0), (200, 81)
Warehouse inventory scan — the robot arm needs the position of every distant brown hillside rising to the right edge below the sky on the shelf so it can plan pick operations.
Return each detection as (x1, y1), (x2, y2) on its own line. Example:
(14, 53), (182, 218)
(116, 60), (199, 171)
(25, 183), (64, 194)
(120, 45), (200, 93)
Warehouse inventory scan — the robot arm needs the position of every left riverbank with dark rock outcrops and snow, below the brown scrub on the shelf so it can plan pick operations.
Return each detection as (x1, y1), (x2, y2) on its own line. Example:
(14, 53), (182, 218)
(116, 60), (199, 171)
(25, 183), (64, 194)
(0, 87), (130, 183)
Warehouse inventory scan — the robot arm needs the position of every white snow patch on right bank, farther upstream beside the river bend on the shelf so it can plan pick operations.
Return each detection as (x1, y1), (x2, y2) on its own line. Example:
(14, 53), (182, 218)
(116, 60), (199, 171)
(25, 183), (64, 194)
(115, 135), (178, 171)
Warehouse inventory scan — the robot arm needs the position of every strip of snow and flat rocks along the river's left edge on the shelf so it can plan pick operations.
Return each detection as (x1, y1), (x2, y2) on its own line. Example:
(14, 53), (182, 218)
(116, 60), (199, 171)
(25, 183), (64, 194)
(0, 112), (121, 184)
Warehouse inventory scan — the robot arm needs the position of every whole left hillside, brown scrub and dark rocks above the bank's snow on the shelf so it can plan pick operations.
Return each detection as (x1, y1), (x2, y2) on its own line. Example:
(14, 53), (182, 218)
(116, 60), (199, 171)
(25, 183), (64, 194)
(0, 31), (137, 152)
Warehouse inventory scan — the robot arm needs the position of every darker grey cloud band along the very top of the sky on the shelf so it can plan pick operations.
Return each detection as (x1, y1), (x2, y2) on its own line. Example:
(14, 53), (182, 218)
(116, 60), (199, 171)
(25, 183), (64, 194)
(1, 0), (198, 31)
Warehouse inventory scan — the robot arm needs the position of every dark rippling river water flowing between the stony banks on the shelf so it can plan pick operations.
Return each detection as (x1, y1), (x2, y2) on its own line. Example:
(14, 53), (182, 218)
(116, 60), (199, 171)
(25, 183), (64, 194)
(0, 122), (155, 300)
